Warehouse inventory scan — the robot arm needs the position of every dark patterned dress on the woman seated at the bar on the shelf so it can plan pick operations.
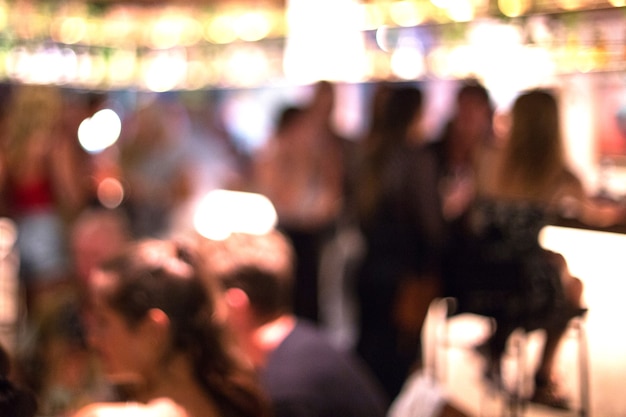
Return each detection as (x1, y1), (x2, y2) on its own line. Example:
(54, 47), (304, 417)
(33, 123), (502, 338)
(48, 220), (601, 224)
(451, 198), (566, 330)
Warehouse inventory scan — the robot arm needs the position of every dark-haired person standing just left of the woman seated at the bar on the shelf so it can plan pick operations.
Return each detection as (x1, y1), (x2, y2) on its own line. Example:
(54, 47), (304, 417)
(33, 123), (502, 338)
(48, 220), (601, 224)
(413, 79), (499, 328)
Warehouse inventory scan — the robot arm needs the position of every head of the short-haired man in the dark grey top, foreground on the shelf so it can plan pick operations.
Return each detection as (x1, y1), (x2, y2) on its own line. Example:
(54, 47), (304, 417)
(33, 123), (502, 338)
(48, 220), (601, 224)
(203, 230), (295, 325)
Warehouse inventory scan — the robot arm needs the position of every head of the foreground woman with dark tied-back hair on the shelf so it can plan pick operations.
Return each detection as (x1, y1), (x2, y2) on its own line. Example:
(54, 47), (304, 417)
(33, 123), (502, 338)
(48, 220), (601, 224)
(89, 240), (214, 383)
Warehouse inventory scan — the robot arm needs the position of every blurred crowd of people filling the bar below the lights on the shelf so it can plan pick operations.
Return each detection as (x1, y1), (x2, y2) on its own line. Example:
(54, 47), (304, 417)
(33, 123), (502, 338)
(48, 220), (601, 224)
(0, 80), (626, 417)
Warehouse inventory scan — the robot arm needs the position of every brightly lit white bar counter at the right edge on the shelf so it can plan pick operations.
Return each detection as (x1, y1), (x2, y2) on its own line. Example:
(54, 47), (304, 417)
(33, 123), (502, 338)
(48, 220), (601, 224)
(531, 219), (626, 416)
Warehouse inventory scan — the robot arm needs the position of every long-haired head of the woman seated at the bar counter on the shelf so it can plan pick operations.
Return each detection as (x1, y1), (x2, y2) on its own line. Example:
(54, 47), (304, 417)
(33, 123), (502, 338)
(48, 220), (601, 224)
(501, 89), (564, 195)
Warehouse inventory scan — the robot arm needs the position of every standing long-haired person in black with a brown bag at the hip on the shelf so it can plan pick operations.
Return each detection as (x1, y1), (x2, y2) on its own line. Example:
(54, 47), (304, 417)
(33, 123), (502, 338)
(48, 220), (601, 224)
(355, 86), (438, 398)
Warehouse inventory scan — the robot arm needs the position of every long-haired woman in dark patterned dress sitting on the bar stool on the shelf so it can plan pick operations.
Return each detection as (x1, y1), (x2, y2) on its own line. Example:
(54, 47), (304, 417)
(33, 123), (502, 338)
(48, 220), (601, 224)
(460, 90), (625, 409)
